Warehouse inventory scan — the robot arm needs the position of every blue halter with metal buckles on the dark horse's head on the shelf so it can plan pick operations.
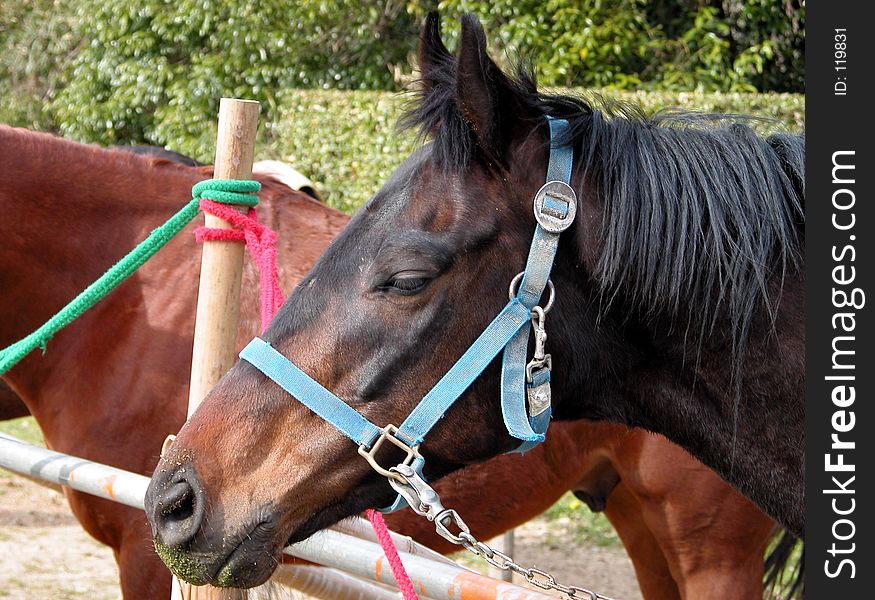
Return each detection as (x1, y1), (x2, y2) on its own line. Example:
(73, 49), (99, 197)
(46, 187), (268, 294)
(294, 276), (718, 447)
(240, 117), (577, 512)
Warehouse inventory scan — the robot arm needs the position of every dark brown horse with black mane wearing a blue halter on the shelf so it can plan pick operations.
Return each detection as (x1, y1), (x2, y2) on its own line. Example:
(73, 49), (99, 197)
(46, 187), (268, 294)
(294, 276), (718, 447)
(146, 10), (805, 587)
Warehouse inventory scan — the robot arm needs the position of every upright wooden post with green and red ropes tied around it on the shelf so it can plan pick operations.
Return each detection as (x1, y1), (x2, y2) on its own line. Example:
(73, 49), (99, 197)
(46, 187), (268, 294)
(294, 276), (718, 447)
(173, 98), (260, 600)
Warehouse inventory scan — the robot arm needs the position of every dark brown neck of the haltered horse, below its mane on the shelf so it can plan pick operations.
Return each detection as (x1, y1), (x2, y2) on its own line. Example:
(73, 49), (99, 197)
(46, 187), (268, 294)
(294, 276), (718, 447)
(562, 151), (805, 534)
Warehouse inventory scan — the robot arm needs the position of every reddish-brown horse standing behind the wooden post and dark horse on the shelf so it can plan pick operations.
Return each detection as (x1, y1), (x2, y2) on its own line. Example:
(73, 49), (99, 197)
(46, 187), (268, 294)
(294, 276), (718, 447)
(0, 127), (788, 600)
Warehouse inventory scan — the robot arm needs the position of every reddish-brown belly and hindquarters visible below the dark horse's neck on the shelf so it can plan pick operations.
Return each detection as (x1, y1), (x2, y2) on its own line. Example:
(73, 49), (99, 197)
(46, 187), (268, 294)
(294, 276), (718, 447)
(386, 421), (775, 600)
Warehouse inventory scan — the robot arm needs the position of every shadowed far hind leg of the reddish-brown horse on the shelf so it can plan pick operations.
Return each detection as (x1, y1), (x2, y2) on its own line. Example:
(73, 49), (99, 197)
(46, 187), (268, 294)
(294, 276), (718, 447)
(605, 481), (684, 600)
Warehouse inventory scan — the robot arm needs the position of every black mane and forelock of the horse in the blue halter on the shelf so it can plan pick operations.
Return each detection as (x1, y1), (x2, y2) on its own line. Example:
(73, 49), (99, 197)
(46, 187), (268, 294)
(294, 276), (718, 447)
(400, 64), (805, 381)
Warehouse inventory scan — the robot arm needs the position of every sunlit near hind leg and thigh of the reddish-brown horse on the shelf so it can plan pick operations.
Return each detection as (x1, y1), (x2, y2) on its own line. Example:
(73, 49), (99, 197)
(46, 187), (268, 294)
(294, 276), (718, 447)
(609, 432), (774, 600)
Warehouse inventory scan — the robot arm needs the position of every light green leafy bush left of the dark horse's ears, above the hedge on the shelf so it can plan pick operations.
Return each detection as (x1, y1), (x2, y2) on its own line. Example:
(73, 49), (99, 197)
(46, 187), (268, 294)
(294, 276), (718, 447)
(27, 0), (418, 154)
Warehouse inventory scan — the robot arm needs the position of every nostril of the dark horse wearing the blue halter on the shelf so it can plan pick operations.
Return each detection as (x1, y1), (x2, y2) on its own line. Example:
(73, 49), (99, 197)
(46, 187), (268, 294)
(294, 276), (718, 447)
(147, 469), (204, 547)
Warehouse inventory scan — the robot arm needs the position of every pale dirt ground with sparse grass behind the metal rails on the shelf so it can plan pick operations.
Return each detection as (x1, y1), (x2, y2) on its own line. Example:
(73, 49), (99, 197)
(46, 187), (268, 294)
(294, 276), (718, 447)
(0, 419), (641, 600)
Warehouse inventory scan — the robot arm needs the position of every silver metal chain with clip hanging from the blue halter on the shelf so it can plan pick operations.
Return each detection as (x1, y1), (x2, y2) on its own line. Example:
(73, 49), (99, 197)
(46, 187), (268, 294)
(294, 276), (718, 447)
(389, 465), (613, 600)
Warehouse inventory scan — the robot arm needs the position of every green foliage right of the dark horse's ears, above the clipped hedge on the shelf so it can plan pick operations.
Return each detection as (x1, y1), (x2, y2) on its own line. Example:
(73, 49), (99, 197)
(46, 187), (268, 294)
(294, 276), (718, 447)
(440, 0), (805, 92)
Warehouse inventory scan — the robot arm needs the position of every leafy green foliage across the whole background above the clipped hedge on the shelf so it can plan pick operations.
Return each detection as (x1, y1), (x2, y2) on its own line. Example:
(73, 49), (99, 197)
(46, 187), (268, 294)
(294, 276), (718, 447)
(0, 0), (804, 154)
